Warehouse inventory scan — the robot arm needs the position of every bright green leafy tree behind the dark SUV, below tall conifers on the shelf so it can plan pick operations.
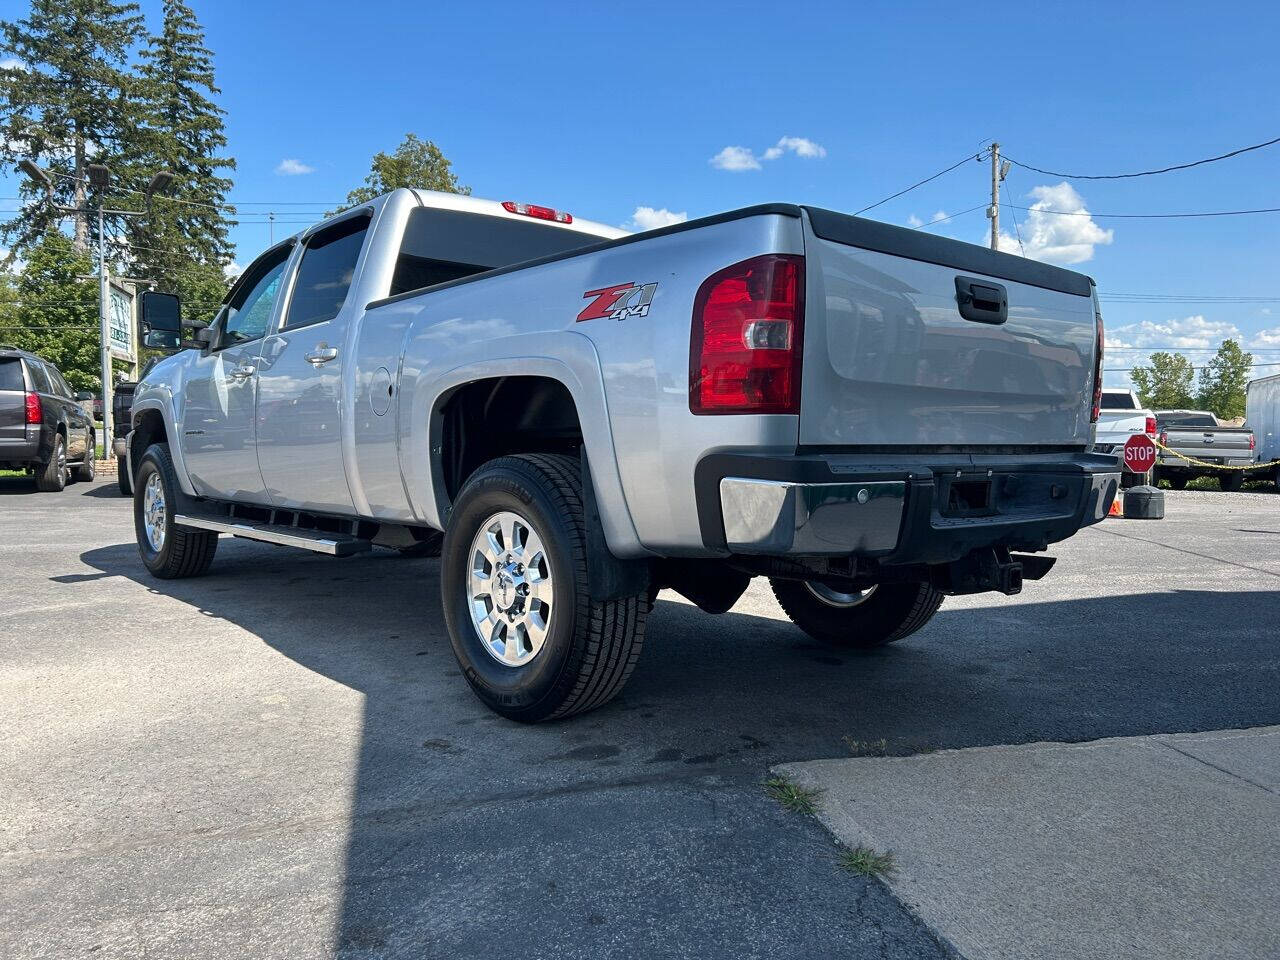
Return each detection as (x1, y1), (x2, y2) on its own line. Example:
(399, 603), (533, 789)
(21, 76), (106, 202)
(0, 230), (101, 393)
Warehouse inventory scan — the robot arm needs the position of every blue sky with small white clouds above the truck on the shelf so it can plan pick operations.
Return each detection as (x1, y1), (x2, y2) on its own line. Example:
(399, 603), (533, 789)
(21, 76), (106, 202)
(5, 0), (1280, 383)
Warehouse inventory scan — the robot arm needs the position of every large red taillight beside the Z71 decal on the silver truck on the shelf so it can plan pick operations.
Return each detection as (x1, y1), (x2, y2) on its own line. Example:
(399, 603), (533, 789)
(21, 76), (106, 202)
(689, 253), (804, 413)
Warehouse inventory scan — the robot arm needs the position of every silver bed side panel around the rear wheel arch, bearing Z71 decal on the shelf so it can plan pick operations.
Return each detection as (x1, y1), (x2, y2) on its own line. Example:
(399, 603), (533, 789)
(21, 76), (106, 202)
(378, 209), (804, 557)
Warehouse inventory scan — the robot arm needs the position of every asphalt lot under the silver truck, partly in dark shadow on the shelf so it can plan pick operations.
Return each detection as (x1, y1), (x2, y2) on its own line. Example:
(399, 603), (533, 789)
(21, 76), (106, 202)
(0, 480), (1280, 957)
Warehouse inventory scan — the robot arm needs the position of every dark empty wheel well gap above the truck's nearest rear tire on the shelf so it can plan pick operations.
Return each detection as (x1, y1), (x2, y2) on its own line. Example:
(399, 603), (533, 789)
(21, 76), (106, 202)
(433, 376), (582, 502)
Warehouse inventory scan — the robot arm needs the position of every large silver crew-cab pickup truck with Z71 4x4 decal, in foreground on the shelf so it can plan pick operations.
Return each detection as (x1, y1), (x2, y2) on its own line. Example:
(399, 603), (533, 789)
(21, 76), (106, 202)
(127, 189), (1120, 721)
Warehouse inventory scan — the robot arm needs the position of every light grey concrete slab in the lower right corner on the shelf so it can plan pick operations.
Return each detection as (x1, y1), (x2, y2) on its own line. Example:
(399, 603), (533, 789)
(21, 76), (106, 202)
(777, 727), (1280, 960)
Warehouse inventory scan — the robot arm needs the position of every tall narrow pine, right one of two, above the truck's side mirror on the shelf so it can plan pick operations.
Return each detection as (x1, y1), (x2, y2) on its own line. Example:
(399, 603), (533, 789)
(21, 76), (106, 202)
(127, 0), (236, 316)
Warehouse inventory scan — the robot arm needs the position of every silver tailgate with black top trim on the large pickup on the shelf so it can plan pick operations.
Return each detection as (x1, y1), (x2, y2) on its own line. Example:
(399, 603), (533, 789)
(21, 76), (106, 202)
(800, 210), (1097, 448)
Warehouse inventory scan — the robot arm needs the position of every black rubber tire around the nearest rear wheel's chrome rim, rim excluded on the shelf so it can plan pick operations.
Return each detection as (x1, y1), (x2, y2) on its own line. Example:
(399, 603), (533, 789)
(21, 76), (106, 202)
(440, 454), (650, 723)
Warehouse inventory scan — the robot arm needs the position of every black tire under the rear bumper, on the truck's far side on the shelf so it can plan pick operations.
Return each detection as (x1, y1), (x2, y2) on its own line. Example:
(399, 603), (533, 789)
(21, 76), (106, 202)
(769, 579), (942, 650)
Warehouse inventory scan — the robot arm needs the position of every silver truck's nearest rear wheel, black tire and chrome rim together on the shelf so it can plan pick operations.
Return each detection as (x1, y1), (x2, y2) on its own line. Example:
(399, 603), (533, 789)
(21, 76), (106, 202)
(440, 454), (650, 723)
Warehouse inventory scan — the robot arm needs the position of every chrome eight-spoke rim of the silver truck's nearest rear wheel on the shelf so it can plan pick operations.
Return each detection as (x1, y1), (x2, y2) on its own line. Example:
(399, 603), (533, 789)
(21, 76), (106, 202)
(467, 511), (556, 667)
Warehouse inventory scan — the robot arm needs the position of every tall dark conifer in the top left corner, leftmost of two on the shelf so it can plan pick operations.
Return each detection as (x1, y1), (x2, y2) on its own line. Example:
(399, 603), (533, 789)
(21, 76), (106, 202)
(0, 0), (143, 261)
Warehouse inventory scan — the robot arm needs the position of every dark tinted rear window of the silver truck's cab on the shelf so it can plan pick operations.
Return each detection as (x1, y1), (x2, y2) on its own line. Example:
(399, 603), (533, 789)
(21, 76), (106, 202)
(389, 207), (603, 297)
